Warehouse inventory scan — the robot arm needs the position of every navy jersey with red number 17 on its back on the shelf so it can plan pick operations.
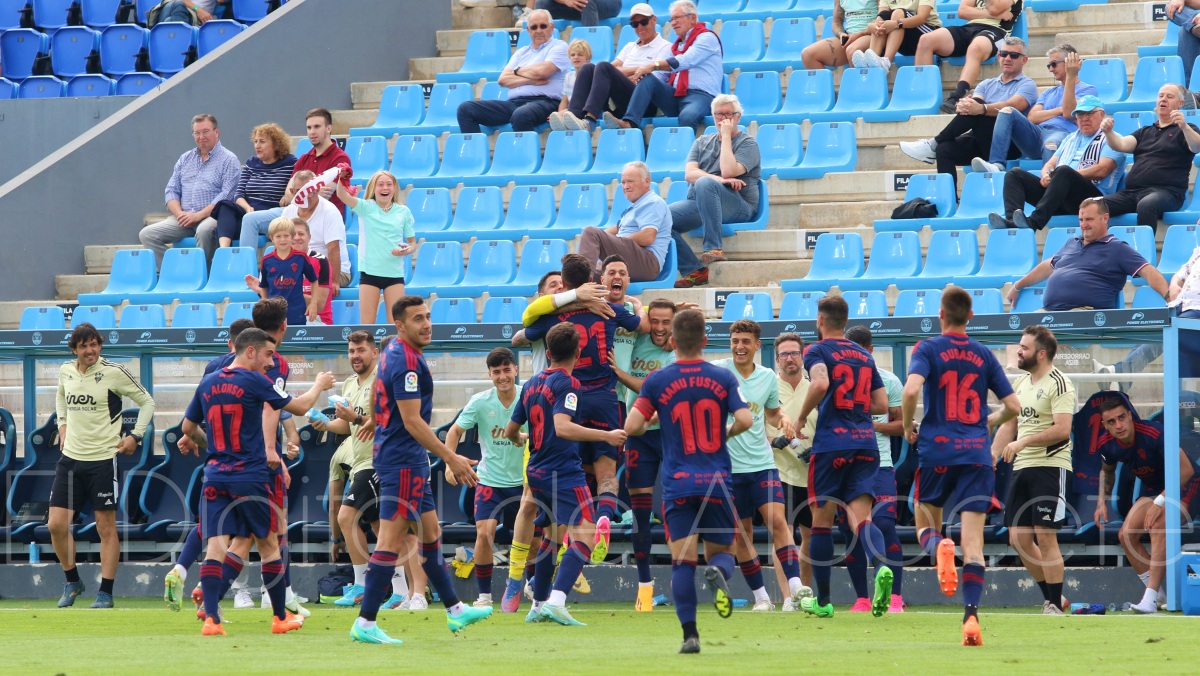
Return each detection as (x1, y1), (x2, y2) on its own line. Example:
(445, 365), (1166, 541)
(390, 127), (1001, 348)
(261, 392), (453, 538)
(184, 366), (292, 481)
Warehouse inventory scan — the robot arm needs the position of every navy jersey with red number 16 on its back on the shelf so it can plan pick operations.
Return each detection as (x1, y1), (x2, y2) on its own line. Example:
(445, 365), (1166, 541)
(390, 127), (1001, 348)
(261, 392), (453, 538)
(908, 334), (1013, 467)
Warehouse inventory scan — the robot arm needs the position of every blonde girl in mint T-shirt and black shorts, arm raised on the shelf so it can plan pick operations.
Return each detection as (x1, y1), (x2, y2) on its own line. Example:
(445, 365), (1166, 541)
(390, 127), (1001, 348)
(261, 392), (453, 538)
(337, 167), (416, 324)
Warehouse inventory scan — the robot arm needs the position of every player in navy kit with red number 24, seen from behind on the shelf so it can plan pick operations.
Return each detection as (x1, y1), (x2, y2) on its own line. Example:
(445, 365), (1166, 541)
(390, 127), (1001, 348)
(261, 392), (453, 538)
(800, 295), (892, 617)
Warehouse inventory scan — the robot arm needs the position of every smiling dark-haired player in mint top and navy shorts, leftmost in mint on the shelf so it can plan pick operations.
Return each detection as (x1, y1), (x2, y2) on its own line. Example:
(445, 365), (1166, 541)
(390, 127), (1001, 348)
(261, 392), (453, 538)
(446, 347), (524, 608)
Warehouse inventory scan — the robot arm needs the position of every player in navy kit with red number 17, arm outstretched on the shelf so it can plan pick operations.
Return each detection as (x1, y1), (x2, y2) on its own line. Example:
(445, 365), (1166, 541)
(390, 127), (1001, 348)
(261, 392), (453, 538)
(179, 329), (334, 636)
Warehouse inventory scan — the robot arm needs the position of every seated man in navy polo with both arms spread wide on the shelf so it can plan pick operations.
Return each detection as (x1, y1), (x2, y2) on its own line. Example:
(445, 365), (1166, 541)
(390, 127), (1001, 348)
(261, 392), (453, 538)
(1008, 197), (1166, 312)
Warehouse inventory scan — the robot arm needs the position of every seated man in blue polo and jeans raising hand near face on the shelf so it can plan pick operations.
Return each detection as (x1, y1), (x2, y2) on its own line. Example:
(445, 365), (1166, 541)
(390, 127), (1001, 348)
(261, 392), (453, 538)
(971, 44), (1098, 172)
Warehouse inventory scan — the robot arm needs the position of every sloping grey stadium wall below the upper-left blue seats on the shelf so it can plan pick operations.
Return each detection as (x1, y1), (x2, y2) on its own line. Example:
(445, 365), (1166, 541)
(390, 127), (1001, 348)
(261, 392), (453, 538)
(0, 0), (450, 300)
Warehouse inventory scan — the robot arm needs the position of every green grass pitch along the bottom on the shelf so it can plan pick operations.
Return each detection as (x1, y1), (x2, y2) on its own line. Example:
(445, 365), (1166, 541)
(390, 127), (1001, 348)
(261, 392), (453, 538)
(0, 600), (1200, 676)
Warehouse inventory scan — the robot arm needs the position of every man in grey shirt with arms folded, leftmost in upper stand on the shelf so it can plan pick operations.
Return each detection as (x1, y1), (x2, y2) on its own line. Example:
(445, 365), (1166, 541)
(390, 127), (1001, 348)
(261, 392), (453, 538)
(458, 10), (571, 133)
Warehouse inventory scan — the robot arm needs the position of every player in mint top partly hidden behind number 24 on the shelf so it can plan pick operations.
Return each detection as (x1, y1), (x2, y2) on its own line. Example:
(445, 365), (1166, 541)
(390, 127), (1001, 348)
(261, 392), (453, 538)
(846, 325), (904, 612)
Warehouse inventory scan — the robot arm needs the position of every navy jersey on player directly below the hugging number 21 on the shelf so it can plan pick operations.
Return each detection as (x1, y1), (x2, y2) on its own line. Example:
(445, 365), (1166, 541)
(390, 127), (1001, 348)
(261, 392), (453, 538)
(512, 369), (583, 481)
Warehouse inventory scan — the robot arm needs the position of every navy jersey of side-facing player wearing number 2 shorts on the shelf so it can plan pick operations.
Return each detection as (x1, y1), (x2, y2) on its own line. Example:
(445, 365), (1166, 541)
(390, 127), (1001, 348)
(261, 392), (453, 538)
(374, 339), (433, 469)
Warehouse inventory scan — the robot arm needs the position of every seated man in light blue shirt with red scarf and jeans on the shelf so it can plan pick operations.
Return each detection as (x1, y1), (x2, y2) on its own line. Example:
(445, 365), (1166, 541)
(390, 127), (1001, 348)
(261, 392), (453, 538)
(604, 0), (725, 128)
